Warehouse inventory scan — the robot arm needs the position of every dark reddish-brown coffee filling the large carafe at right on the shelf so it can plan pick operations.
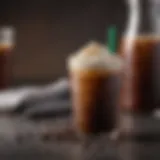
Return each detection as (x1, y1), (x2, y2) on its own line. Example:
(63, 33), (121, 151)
(120, 36), (160, 112)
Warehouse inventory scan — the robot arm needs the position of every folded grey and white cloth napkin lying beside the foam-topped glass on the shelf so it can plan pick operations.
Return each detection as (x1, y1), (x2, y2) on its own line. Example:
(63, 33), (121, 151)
(0, 78), (71, 117)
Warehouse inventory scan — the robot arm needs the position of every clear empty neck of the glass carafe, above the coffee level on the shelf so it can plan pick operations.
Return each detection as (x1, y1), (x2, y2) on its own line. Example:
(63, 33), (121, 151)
(125, 0), (156, 37)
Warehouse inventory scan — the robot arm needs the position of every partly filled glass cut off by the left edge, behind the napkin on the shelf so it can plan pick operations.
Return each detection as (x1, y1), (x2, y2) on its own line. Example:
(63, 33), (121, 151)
(0, 27), (15, 89)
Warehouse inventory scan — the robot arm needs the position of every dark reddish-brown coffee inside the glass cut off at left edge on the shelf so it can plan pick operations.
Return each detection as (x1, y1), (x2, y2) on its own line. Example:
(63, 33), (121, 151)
(0, 46), (11, 89)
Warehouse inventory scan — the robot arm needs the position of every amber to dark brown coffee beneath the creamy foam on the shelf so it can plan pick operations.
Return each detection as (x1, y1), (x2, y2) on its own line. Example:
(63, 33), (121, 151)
(71, 71), (117, 134)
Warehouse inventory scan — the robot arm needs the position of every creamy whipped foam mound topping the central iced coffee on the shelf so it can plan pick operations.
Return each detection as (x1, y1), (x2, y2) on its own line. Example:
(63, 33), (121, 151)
(68, 42), (123, 71)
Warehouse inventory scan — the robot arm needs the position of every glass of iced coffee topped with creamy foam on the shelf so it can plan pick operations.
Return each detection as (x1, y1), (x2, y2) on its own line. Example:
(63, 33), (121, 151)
(68, 42), (122, 134)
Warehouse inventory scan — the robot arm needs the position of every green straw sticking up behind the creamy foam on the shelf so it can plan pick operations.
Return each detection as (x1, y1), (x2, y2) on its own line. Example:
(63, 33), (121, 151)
(107, 26), (117, 54)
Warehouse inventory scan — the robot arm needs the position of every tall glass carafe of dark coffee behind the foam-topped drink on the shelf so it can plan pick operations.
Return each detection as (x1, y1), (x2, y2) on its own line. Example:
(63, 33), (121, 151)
(119, 0), (160, 113)
